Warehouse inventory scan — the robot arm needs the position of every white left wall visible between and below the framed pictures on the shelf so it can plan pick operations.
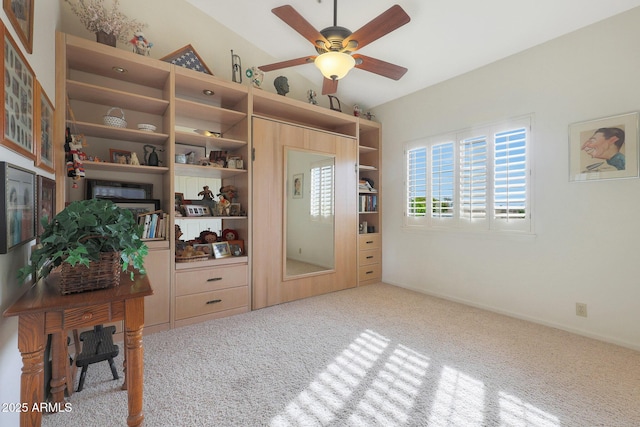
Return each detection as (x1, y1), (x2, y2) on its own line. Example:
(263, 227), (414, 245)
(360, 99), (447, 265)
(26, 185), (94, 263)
(0, 1), (61, 426)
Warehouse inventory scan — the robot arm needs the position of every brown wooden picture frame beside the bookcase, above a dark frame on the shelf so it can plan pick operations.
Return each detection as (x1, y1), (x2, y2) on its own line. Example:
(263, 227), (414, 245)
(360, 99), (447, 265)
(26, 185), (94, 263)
(33, 80), (55, 173)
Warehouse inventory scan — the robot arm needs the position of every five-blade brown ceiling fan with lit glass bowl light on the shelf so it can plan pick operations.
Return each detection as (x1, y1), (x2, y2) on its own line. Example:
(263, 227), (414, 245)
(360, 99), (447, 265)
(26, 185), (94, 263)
(258, 0), (411, 95)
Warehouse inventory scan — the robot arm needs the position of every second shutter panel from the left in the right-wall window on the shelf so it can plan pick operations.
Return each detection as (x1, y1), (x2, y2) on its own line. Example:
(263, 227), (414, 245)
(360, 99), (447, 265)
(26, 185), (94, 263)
(431, 142), (455, 218)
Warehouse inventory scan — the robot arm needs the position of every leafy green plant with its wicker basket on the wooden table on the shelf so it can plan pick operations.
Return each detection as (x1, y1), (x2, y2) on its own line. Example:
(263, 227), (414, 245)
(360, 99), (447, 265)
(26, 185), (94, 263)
(18, 199), (148, 294)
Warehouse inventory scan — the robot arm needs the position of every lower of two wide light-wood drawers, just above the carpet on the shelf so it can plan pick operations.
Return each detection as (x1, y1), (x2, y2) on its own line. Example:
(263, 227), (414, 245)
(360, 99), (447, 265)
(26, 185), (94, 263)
(176, 286), (249, 320)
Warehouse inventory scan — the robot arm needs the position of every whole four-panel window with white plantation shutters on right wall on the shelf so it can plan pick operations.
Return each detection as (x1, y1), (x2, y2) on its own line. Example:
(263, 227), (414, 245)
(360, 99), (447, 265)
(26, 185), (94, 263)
(405, 117), (532, 233)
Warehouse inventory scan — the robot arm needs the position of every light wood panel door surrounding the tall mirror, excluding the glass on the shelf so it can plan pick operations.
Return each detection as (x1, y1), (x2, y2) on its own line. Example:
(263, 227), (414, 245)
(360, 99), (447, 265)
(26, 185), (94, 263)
(252, 117), (358, 309)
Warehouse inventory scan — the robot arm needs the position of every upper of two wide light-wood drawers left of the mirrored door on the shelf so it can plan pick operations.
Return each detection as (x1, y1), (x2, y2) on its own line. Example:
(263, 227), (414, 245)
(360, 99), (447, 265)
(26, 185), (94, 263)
(176, 264), (249, 296)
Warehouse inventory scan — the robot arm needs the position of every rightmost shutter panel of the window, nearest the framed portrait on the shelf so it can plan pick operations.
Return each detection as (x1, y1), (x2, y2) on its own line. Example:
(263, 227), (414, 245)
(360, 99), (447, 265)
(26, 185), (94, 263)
(493, 128), (528, 221)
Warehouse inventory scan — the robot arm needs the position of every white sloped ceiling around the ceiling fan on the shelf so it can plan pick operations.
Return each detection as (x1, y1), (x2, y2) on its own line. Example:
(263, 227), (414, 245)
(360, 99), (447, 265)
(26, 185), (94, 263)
(187, 0), (640, 108)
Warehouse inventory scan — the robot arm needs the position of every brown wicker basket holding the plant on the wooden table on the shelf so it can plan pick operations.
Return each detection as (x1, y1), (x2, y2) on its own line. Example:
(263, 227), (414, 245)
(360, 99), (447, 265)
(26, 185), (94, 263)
(60, 252), (122, 295)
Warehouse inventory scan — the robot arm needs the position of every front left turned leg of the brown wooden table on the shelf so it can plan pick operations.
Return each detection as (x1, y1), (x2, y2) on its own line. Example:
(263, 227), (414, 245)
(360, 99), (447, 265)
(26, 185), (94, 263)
(18, 313), (45, 427)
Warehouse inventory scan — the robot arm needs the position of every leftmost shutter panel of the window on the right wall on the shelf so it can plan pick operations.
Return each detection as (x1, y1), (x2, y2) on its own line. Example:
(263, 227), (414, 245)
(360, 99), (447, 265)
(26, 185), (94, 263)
(406, 147), (427, 217)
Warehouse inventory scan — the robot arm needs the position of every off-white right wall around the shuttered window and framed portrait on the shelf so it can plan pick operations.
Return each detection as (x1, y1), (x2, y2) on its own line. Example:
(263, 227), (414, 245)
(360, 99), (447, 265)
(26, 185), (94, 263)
(376, 8), (640, 349)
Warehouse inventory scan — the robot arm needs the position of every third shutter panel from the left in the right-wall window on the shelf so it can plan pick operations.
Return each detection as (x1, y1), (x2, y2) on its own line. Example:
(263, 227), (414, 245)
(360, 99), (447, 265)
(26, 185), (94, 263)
(460, 136), (488, 221)
